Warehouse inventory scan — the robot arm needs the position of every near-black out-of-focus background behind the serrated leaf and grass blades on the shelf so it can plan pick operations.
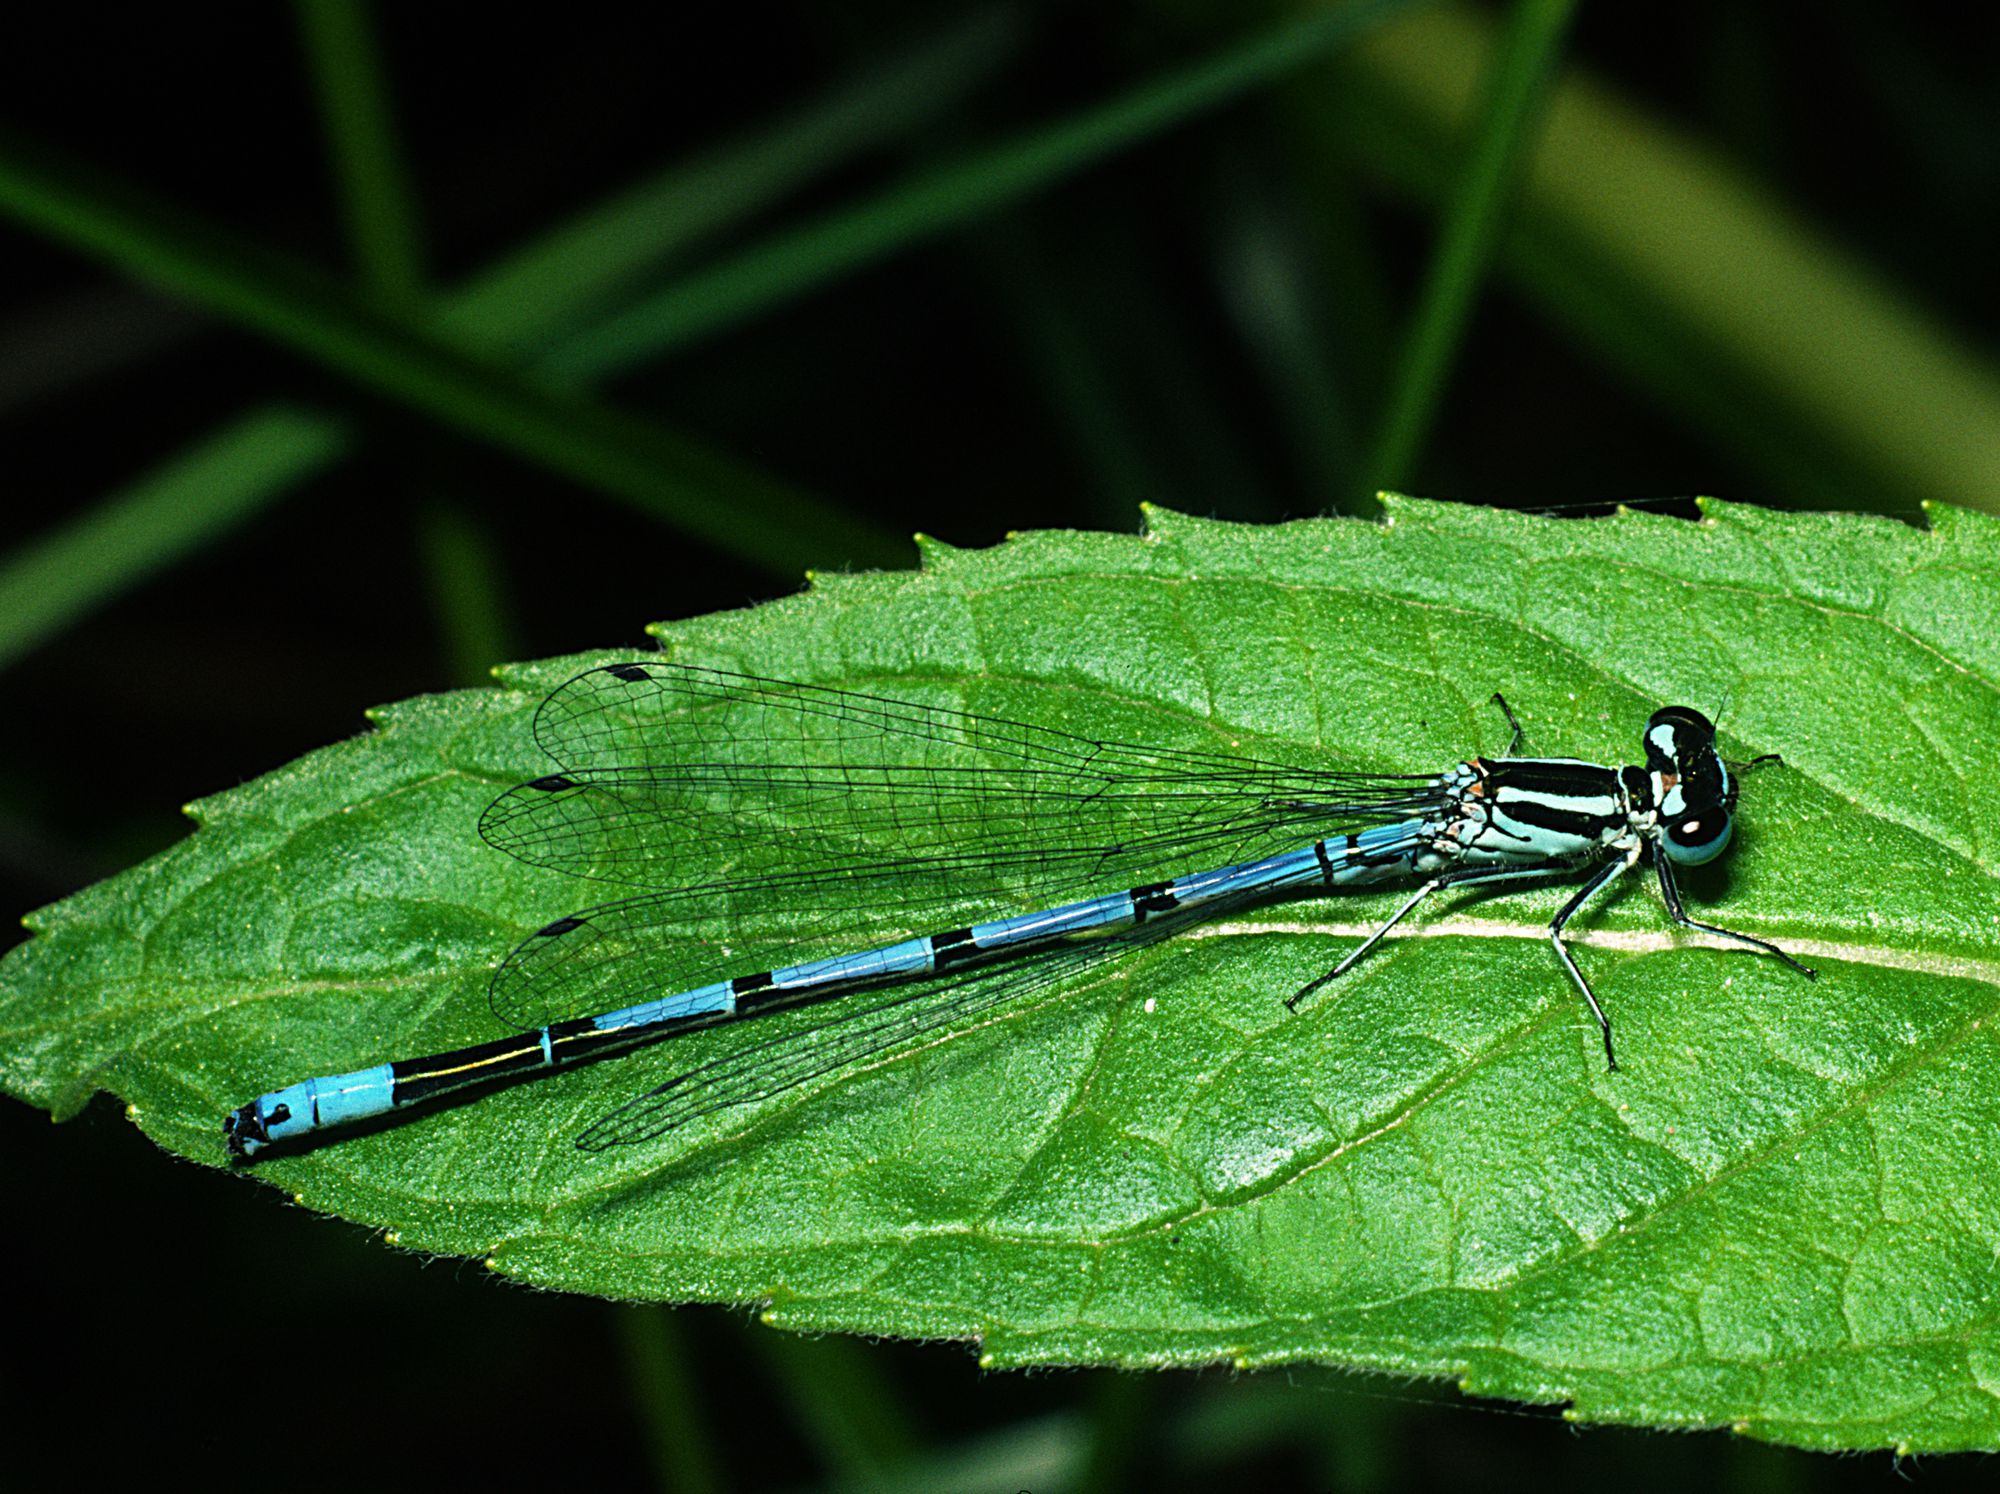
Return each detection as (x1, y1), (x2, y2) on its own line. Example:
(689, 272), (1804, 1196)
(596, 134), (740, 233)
(0, 0), (2000, 1490)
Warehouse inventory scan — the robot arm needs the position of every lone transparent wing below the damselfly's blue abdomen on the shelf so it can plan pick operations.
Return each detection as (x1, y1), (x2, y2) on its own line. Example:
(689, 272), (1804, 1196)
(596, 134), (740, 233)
(576, 896), (1254, 1152)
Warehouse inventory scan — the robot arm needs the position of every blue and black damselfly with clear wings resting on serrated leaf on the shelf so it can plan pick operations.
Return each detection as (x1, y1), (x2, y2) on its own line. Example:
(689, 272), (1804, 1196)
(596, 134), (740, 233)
(224, 662), (1812, 1156)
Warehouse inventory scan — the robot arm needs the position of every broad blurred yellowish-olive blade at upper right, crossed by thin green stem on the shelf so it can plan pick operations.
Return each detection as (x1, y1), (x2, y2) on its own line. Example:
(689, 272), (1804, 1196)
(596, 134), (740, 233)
(1314, 6), (2000, 514)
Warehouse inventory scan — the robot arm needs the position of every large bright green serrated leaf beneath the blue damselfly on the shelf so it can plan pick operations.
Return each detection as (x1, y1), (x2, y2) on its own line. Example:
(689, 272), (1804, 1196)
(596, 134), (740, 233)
(0, 498), (2000, 1450)
